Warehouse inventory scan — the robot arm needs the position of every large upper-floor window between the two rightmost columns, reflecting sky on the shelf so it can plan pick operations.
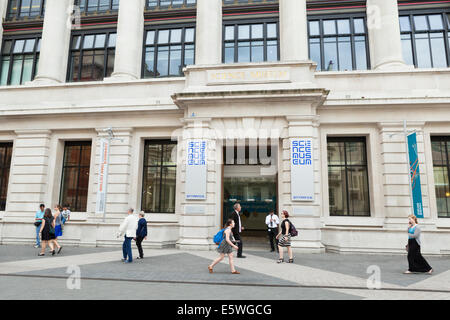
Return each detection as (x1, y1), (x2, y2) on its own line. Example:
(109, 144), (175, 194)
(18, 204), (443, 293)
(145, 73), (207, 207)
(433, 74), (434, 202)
(308, 17), (369, 71)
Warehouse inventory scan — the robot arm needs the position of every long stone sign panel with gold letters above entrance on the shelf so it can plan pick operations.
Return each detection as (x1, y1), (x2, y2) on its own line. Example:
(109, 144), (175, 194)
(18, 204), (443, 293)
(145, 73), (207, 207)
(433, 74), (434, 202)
(207, 68), (291, 85)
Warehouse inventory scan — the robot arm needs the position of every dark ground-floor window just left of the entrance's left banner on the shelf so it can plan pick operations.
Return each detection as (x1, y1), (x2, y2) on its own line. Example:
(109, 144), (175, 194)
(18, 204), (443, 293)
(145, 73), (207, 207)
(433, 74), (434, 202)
(141, 141), (177, 213)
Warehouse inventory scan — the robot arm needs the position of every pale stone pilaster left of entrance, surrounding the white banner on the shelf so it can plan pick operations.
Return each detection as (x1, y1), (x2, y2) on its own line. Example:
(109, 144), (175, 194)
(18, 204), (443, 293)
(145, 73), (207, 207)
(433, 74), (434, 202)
(176, 119), (222, 250)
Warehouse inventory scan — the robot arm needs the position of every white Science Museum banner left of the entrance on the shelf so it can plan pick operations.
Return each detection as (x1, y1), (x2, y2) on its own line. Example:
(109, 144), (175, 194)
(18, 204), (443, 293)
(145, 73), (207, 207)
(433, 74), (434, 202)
(185, 140), (208, 200)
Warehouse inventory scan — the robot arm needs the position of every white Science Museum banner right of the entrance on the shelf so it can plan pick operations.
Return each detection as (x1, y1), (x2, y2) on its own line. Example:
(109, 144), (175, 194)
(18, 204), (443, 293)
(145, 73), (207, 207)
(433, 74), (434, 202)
(290, 138), (314, 201)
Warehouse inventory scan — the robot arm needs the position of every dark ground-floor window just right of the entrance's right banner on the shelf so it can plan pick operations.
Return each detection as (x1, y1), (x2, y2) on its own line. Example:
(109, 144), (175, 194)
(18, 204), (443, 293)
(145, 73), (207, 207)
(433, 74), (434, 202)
(327, 138), (370, 217)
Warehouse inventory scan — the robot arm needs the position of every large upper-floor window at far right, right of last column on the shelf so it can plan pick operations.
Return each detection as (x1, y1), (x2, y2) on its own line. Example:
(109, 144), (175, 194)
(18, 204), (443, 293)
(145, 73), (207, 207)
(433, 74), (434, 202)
(400, 12), (450, 68)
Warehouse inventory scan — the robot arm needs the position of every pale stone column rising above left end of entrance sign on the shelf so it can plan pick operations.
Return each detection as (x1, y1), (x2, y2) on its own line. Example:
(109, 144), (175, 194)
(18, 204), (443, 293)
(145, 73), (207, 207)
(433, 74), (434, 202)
(195, 0), (222, 65)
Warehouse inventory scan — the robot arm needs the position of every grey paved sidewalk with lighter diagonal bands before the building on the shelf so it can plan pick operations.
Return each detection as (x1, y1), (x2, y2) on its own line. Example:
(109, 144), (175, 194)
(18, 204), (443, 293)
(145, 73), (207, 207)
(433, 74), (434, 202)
(0, 245), (450, 300)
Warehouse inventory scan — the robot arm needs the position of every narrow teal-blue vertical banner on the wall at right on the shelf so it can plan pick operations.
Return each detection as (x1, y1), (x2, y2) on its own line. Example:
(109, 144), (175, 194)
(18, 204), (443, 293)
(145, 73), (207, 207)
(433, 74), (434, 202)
(408, 133), (423, 218)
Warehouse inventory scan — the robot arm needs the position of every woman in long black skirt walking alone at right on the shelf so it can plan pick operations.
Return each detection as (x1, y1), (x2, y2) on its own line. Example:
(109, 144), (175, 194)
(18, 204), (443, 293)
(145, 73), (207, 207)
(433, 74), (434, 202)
(405, 215), (433, 274)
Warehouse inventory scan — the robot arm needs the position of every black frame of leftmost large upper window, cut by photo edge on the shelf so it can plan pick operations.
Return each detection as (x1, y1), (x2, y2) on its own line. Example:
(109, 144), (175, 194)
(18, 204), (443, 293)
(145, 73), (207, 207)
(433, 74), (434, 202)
(0, 33), (42, 86)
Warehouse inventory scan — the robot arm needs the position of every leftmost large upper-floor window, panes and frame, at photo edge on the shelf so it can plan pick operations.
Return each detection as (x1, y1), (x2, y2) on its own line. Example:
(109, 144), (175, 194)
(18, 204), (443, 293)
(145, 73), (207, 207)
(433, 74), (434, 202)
(0, 37), (41, 86)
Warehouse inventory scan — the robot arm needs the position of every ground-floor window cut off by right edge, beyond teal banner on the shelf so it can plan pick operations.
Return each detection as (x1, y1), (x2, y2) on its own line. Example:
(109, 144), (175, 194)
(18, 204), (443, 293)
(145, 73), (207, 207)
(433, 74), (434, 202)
(431, 136), (450, 218)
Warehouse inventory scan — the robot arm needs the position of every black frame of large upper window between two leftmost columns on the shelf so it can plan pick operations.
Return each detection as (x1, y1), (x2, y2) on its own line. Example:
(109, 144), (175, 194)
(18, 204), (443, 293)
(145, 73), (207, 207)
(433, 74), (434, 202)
(66, 28), (117, 83)
